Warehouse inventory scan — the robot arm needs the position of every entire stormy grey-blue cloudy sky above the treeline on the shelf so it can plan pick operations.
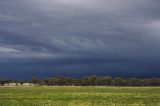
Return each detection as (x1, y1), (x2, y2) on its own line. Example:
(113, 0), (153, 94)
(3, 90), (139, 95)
(0, 0), (160, 79)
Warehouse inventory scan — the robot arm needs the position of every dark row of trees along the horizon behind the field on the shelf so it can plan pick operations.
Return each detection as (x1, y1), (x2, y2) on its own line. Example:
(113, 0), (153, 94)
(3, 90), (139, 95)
(0, 76), (160, 86)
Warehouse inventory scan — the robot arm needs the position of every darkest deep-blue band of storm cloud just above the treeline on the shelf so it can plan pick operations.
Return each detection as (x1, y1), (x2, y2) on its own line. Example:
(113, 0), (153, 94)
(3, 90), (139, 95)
(0, 63), (160, 79)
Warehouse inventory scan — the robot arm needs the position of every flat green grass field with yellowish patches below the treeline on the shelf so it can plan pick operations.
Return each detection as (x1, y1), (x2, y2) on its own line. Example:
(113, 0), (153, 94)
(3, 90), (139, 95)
(0, 87), (160, 106)
